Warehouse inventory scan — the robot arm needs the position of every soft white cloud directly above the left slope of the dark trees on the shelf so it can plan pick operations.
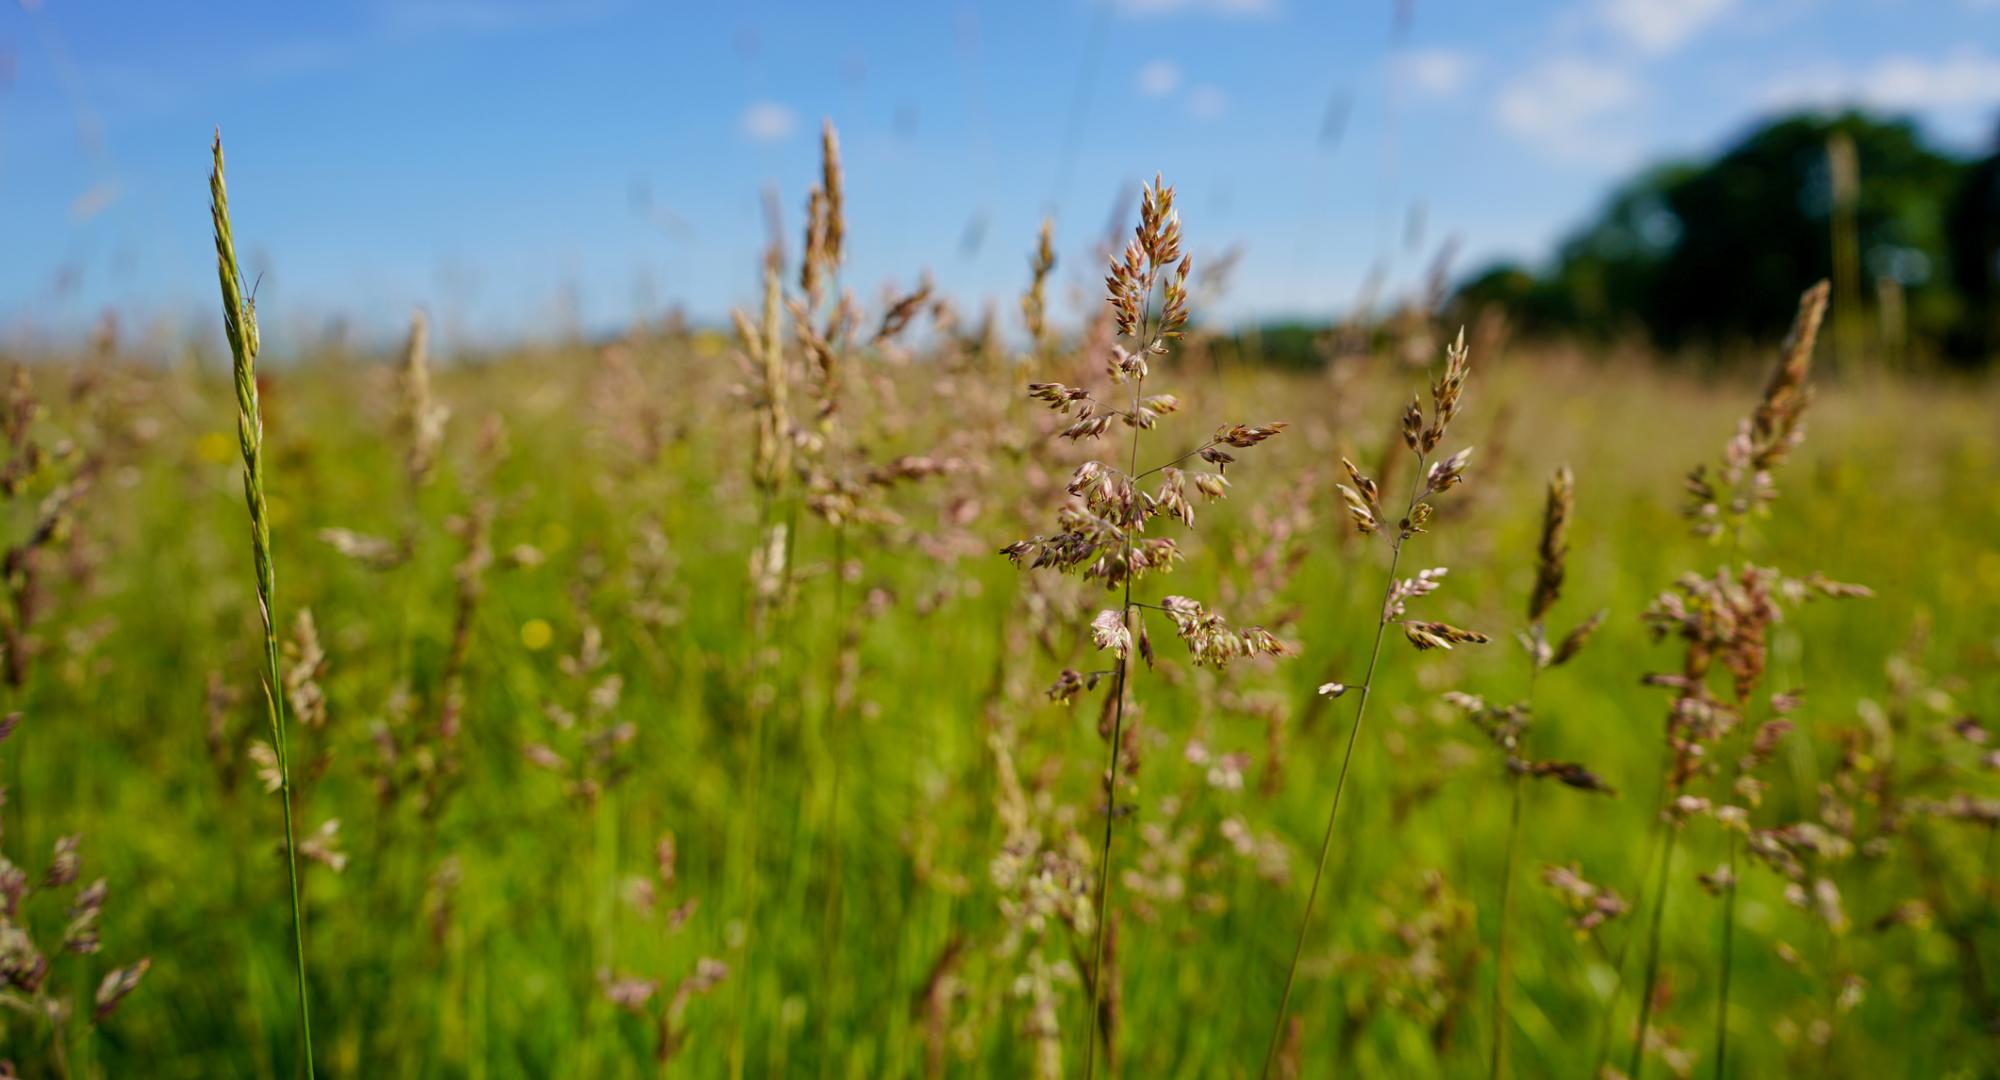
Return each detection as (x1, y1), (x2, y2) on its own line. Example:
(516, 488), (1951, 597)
(1494, 56), (1642, 166)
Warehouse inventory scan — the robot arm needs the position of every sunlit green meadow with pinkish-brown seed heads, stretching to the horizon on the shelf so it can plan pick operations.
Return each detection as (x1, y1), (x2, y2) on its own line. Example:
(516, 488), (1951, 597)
(0, 156), (2000, 1078)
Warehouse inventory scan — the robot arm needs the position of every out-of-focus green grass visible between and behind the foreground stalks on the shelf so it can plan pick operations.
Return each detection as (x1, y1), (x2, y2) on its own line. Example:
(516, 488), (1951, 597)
(4, 334), (2000, 1076)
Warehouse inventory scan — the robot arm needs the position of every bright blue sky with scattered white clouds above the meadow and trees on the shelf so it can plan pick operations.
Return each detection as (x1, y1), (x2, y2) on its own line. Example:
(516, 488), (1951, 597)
(0, 0), (2000, 348)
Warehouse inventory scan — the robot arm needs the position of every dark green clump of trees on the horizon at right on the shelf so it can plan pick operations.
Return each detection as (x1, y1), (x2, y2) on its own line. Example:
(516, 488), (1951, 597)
(1458, 112), (1996, 362)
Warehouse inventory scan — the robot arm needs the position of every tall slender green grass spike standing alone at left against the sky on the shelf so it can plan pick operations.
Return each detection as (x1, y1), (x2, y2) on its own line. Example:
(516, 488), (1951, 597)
(208, 130), (314, 1080)
